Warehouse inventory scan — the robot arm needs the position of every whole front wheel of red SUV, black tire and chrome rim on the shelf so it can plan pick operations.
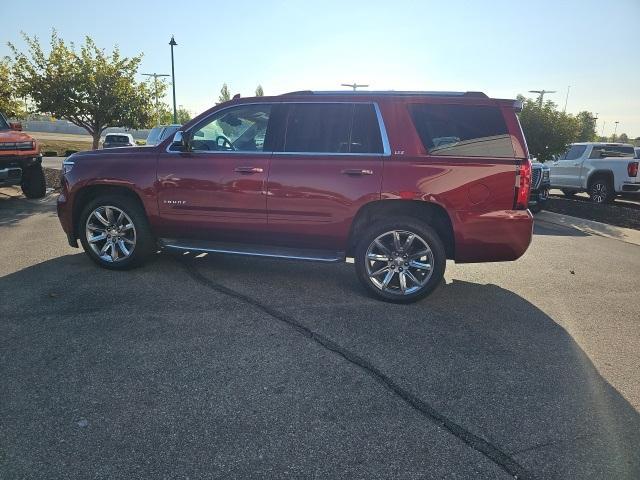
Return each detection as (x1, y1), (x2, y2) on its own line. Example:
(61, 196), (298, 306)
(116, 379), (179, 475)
(77, 195), (155, 270)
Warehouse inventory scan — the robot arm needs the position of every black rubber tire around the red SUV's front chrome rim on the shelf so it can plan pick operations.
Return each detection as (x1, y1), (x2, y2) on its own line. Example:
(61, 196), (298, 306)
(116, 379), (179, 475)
(76, 194), (157, 270)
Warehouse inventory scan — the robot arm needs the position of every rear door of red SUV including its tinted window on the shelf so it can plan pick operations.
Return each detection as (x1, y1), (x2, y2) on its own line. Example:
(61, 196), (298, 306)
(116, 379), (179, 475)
(267, 102), (388, 251)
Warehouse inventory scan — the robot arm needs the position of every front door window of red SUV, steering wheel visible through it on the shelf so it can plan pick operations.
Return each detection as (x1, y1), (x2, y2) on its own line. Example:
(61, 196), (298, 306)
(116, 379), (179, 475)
(191, 104), (271, 152)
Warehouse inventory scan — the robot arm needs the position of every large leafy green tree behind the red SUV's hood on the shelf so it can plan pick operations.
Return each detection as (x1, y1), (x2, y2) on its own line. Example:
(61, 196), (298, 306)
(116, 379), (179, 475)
(9, 31), (154, 149)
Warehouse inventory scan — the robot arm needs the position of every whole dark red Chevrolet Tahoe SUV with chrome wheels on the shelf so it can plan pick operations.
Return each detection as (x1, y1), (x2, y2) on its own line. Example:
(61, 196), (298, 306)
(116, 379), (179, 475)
(58, 91), (532, 302)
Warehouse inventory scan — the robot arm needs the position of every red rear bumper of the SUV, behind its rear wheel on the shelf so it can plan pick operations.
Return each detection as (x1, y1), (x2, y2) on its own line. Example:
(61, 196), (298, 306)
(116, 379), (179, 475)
(453, 210), (533, 263)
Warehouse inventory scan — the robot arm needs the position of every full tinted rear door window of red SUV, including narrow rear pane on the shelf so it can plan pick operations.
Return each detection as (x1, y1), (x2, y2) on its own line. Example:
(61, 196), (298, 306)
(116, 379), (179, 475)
(284, 103), (382, 154)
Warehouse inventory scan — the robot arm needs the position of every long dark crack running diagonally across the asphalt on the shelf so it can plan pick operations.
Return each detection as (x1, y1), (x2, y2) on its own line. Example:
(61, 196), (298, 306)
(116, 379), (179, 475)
(174, 257), (534, 480)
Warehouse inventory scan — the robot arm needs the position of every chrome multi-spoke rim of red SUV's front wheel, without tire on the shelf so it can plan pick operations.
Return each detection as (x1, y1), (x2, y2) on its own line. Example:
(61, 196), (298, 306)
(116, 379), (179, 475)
(85, 205), (136, 263)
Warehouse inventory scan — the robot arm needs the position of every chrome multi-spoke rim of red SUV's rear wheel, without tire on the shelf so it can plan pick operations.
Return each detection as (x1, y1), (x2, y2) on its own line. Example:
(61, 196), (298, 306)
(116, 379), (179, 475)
(365, 230), (434, 295)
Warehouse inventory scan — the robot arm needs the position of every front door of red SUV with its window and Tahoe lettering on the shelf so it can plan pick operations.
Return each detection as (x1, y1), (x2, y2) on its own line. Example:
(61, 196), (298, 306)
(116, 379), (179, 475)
(157, 103), (271, 242)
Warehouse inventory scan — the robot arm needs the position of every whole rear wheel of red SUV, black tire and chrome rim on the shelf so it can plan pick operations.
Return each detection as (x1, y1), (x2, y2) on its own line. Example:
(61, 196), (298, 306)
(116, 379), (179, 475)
(355, 218), (446, 303)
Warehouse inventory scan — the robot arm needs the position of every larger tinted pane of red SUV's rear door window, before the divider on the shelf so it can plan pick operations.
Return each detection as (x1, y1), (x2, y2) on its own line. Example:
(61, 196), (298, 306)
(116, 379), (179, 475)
(284, 103), (353, 153)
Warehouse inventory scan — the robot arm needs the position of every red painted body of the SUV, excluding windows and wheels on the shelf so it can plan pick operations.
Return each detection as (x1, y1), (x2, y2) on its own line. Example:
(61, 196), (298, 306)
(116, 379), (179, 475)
(58, 91), (533, 262)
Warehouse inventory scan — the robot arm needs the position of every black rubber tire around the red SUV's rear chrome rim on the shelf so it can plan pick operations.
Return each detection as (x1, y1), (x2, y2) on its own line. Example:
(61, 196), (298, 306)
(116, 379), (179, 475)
(355, 217), (447, 303)
